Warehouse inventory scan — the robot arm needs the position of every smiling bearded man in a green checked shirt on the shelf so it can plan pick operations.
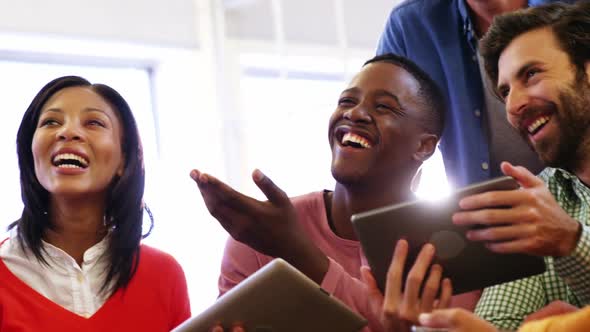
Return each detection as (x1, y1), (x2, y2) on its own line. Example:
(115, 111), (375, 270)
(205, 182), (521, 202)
(416, 3), (590, 330)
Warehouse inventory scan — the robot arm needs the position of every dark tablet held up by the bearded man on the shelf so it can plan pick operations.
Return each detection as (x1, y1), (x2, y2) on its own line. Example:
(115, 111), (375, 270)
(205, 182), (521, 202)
(352, 177), (545, 294)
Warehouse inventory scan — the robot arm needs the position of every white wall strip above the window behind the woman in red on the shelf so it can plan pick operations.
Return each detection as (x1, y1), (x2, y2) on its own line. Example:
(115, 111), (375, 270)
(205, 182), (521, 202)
(0, 0), (199, 48)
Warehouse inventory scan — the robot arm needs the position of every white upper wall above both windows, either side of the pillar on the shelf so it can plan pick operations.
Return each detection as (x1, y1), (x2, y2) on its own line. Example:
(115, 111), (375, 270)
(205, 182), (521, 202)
(0, 0), (400, 49)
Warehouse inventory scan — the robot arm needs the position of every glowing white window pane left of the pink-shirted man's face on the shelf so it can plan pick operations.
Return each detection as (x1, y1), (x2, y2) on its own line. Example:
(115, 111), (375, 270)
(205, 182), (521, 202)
(241, 76), (342, 198)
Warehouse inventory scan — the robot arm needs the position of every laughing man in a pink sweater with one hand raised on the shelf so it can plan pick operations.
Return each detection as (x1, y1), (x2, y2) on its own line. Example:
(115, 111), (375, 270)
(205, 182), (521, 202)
(191, 55), (451, 331)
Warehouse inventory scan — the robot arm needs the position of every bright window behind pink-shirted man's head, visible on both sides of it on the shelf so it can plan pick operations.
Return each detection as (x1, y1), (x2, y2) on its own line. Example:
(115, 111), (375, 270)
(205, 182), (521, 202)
(239, 54), (449, 199)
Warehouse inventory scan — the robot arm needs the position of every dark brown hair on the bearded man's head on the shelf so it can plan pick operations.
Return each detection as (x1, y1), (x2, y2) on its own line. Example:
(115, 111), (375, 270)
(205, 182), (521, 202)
(479, 1), (590, 86)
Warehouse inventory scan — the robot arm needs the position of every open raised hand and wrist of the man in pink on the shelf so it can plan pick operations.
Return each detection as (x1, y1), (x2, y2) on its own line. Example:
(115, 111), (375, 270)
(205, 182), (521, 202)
(191, 170), (328, 283)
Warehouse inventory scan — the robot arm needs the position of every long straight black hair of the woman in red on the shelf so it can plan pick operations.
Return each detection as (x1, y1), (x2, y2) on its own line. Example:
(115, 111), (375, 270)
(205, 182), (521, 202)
(9, 76), (153, 292)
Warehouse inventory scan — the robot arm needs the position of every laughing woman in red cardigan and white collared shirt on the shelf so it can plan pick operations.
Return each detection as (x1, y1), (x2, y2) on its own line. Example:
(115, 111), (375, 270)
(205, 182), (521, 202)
(0, 76), (190, 331)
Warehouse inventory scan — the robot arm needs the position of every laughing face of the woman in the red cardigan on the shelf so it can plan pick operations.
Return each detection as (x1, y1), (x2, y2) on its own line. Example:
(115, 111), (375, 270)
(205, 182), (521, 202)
(31, 87), (125, 200)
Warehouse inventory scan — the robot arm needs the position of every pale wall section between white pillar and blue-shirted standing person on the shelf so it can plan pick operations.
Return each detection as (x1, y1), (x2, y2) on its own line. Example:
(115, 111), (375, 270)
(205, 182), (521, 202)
(225, 0), (400, 50)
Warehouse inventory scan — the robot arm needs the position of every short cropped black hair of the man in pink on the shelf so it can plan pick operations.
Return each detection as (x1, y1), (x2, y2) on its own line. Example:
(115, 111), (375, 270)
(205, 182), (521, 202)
(363, 53), (447, 138)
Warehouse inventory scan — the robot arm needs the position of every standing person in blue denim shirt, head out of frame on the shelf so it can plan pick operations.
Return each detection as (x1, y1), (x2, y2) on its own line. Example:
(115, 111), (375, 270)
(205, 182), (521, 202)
(377, 0), (573, 187)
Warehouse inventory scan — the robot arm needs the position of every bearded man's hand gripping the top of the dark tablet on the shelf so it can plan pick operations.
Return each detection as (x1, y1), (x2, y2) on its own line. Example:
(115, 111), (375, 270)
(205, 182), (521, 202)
(453, 162), (582, 257)
